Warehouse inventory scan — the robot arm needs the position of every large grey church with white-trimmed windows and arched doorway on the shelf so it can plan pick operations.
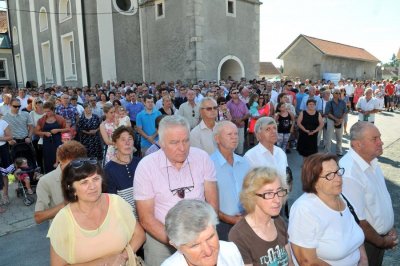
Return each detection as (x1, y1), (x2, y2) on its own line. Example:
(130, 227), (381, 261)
(8, 0), (261, 86)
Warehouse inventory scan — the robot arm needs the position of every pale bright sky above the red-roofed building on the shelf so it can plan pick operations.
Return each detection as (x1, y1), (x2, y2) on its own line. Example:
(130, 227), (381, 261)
(260, 0), (400, 67)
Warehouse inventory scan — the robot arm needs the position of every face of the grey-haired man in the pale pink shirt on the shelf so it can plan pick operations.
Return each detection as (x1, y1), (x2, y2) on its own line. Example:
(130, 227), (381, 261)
(160, 126), (190, 164)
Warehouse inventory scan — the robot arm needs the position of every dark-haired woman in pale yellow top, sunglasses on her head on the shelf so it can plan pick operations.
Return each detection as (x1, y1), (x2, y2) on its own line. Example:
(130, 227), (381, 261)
(47, 158), (145, 265)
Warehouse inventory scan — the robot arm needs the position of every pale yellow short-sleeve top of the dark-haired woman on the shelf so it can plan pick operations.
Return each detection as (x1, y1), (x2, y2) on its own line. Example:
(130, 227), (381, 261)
(47, 194), (136, 264)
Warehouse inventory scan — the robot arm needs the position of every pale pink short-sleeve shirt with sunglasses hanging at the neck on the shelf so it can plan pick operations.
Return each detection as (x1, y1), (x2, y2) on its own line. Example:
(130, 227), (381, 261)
(133, 147), (217, 224)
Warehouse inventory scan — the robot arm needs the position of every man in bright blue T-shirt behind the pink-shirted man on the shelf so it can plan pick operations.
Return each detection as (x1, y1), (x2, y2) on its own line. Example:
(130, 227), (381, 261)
(136, 94), (161, 156)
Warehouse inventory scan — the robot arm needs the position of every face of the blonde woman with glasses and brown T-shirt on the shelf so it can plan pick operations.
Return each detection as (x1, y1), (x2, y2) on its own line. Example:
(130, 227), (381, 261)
(255, 177), (285, 217)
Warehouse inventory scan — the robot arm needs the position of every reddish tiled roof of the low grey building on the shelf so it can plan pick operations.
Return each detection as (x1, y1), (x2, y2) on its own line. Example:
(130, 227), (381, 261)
(300, 35), (380, 62)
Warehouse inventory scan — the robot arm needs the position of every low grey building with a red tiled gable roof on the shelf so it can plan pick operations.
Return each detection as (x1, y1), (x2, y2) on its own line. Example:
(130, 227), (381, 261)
(278, 34), (380, 80)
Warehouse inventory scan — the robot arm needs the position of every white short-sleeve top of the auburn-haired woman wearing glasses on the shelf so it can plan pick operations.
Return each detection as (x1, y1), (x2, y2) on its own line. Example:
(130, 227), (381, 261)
(288, 192), (364, 265)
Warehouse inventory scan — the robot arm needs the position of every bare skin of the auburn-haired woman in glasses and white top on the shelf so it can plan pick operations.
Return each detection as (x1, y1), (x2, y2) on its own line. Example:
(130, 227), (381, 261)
(291, 160), (368, 266)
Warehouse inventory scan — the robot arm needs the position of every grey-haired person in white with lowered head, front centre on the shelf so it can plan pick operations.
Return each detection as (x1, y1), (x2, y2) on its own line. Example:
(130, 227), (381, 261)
(161, 200), (243, 266)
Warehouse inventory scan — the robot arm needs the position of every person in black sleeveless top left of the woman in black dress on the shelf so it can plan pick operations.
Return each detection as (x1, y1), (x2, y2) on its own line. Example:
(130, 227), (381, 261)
(275, 102), (294, 152)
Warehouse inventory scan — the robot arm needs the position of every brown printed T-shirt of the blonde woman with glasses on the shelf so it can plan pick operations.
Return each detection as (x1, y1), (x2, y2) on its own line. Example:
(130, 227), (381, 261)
(229, 216), (289, 266)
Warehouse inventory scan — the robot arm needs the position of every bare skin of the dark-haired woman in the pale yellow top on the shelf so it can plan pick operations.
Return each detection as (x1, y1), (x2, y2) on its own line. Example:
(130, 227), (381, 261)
(50, 173), (146, 266)
